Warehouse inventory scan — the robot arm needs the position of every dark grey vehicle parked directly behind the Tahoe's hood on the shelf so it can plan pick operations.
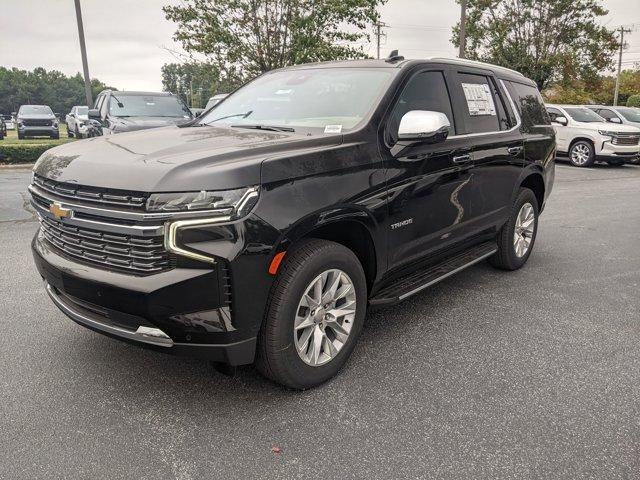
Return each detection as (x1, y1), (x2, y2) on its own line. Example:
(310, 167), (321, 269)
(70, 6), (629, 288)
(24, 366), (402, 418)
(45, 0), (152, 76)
(89, 90), (193, 135)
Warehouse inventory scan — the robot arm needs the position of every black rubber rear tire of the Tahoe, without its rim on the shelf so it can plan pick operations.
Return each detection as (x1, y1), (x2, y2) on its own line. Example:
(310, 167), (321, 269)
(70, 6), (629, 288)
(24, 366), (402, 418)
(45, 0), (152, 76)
(489, 188), (539, 270)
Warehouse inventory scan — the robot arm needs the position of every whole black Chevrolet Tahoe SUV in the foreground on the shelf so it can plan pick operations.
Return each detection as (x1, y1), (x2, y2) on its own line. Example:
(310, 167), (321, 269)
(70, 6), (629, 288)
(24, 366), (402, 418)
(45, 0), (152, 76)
(29, 57), (555, 389)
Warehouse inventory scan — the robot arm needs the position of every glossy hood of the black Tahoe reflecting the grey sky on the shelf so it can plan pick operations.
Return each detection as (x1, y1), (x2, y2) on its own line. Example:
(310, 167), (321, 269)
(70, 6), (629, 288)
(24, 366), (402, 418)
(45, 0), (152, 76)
(34, 126), (342, 192)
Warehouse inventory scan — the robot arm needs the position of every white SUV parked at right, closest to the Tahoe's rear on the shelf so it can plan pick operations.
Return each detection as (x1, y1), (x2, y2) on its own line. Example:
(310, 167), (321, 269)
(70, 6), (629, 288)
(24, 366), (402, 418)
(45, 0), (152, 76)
(547, 105), (640, 167)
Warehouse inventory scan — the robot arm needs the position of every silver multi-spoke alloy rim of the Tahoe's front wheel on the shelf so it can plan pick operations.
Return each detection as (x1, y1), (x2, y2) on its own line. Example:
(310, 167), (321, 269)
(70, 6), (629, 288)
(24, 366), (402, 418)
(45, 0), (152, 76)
(293, 269), (356, 367)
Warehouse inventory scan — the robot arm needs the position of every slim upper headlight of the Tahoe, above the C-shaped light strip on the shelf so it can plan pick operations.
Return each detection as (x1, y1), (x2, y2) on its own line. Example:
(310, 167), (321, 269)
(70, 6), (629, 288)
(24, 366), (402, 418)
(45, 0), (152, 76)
(147, 187), (259, 218)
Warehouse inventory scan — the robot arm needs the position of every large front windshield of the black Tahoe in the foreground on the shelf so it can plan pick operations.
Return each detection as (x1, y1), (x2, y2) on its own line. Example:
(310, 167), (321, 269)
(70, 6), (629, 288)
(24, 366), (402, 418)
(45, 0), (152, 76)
(200, 68), (393, 133)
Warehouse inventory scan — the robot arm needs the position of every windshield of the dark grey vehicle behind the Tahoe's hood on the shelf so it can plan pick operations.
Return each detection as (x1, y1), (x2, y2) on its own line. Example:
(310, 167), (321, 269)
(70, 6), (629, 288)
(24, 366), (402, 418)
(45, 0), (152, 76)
(109, 95), (191, 118)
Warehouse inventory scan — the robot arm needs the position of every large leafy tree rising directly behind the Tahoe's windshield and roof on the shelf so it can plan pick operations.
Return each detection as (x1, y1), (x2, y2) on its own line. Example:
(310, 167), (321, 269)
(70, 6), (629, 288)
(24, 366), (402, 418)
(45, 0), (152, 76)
(163, 0), (385, 79)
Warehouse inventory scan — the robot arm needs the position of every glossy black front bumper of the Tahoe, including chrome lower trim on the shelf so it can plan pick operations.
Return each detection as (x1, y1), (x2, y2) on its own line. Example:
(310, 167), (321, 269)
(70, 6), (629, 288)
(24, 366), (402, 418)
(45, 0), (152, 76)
(32, 210), (272, 365)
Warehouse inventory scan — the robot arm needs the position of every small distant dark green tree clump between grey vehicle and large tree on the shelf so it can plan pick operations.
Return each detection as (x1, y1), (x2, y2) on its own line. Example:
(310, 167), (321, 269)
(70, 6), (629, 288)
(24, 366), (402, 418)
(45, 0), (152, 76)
(162, 61), (240, 108)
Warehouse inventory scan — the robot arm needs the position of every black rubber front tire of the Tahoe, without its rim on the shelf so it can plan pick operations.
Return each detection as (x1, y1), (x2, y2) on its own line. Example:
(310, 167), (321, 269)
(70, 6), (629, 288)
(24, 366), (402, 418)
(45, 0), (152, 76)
(256, 239), (367, 390)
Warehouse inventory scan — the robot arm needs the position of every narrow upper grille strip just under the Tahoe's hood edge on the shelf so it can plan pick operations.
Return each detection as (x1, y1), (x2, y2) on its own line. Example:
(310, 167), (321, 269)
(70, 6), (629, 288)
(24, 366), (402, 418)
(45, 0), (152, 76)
(33, 175), (147, 210)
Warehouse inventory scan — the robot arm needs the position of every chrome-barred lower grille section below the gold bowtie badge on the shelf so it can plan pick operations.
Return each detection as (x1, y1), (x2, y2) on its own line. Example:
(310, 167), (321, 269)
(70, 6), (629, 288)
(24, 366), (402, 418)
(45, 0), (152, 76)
(40, 216), (171, 273)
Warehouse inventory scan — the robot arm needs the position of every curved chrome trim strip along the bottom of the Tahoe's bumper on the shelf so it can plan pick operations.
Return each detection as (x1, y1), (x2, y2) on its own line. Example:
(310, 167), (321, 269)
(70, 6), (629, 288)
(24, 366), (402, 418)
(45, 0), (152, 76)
(45, 281), (173, 347)
